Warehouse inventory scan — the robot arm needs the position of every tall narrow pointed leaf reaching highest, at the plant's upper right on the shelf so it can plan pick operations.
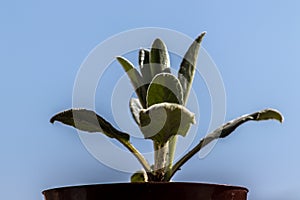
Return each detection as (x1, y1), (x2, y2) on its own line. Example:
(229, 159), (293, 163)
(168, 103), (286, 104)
(178, 32), (205, 104)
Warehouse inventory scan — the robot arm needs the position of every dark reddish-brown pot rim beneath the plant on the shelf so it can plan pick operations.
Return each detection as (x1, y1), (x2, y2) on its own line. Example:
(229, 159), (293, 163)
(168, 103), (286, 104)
(42, 182), (248, 200)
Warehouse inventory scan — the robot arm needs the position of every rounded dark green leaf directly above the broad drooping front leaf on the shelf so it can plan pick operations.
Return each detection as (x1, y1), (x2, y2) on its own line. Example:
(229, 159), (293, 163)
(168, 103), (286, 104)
(147, 73), (183, 107)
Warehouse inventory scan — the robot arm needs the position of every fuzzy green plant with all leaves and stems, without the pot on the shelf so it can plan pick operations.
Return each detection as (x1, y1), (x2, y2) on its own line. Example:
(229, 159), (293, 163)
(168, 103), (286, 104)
(50, 32), (283, 182)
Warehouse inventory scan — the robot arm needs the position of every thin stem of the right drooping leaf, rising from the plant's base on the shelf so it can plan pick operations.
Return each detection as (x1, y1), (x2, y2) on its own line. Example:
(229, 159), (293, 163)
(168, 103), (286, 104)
(166, 137), (216, 181)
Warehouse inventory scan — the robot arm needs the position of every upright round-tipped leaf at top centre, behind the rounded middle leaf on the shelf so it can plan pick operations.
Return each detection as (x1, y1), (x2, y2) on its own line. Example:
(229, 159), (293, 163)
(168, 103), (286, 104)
(150, 39), (171, 78)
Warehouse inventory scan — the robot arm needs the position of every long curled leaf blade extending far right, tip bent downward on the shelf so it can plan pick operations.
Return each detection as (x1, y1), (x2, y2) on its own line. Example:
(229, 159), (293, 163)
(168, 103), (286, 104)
(206, 109), (283, 139)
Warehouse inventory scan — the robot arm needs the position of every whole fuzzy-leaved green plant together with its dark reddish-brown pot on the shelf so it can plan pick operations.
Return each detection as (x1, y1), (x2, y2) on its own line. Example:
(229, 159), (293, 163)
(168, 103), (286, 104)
(43, 32), (283, 200)
